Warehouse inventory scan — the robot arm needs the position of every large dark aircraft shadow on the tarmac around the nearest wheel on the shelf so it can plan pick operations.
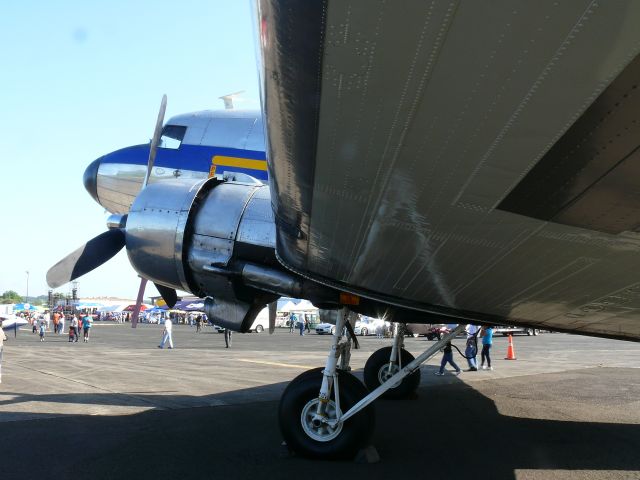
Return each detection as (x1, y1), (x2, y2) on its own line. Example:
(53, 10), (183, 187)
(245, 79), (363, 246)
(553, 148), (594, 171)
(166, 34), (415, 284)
(0, 366), (640, 479)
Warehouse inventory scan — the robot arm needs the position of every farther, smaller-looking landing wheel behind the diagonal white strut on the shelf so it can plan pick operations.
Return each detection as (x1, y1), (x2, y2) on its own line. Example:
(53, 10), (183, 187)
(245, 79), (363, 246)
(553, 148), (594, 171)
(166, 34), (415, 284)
(364, 347), (420, 399)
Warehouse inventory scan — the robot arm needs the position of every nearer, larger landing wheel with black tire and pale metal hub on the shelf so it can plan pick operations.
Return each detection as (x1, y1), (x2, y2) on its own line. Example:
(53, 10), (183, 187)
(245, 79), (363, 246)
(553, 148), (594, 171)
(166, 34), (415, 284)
(278, 368), (375, 460)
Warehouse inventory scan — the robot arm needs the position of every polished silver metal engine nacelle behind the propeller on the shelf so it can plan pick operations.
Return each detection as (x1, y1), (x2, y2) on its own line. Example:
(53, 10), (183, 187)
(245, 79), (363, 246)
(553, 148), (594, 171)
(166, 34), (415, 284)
(126, 178), (275, 297)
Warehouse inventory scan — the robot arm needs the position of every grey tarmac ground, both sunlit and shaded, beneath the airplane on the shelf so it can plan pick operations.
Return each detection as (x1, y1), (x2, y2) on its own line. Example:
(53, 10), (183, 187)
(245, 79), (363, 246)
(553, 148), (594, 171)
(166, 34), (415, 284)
(0, 322), (640, 480)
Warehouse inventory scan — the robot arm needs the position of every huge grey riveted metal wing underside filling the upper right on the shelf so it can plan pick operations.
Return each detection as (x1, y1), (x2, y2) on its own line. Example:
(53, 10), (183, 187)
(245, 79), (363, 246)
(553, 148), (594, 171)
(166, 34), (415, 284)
(257, 0), (640, 341)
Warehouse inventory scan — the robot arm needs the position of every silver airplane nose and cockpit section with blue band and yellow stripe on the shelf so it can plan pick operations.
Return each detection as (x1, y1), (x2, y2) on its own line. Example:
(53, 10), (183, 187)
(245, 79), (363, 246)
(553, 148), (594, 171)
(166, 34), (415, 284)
(83, 109), (268, 214)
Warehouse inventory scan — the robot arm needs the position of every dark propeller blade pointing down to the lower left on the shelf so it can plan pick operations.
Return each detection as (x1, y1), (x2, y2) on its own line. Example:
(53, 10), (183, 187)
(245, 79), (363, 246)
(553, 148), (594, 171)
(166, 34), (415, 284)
(47, 229), (125, 288)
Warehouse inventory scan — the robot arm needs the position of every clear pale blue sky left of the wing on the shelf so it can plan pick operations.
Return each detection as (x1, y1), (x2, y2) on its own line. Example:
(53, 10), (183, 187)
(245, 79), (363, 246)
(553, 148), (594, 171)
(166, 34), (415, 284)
(0, 0), (260, 298)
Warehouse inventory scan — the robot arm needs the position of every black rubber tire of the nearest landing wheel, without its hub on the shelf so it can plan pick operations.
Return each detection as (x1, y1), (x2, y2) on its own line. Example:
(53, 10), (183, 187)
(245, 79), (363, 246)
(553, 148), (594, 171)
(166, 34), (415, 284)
(278, 367), (375, 460)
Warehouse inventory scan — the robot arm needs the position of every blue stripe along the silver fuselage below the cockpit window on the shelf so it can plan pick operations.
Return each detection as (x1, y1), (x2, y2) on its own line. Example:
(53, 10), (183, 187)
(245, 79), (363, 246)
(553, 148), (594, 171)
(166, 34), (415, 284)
(101, 144), (267, 181)
